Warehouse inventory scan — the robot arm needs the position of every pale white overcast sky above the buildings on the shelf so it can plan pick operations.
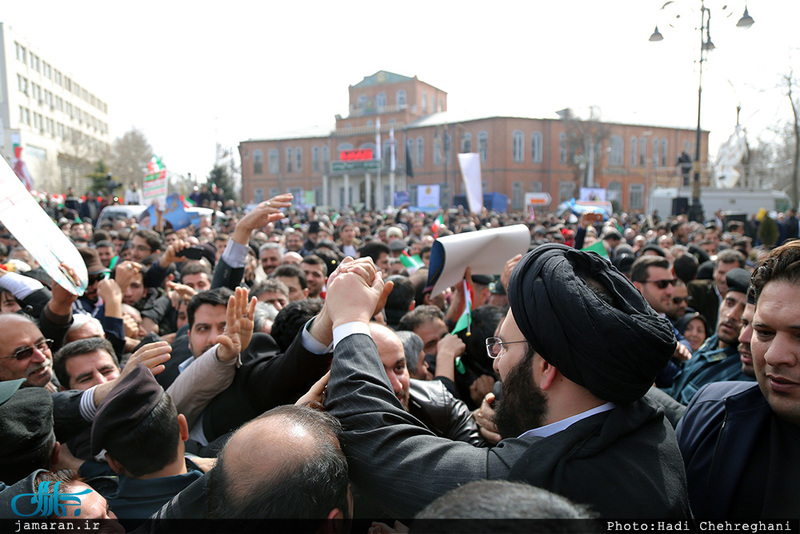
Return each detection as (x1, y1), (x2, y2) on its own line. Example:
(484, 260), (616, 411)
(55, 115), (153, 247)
(0, 0), (800, 184)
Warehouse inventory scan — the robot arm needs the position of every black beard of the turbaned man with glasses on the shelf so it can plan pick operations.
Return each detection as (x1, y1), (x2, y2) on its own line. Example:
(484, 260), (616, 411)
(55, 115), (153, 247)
(494, 356), (547, 438)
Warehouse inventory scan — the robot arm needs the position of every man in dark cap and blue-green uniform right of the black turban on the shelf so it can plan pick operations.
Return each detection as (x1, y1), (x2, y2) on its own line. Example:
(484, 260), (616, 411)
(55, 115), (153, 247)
(664, 267), (753, 404)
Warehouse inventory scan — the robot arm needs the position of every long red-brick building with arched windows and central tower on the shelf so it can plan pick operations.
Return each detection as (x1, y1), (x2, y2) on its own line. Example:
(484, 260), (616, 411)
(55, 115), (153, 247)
(239, 71), (708, 214)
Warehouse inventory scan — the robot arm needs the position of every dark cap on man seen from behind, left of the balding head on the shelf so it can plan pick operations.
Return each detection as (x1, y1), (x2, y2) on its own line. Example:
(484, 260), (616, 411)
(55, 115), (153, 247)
(91, 364), (164, 455)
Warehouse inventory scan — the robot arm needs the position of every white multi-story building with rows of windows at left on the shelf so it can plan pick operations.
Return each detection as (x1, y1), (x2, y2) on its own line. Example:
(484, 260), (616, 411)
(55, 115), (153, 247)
(0, 22), (110, 193)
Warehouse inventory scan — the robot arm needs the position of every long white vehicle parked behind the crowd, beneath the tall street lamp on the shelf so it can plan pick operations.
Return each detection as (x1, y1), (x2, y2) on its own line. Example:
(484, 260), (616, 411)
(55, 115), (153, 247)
(649, 187), (792, 219)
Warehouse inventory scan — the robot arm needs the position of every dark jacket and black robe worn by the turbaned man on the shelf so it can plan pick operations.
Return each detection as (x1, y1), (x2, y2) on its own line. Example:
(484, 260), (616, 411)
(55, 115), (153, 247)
(325, 334), (690, 519)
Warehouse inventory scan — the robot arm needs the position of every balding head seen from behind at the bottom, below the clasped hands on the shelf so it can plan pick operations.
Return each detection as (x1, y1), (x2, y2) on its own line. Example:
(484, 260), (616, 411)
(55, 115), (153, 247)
(209, 405), (352, 519)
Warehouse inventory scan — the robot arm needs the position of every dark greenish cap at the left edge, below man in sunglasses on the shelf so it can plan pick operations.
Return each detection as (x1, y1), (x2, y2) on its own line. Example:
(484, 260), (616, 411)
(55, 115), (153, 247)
(0, 378), (53, 458)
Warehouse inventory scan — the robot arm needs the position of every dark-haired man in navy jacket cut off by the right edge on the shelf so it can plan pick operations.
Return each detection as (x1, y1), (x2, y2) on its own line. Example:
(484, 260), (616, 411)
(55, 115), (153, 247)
(677, 241), (800, 520)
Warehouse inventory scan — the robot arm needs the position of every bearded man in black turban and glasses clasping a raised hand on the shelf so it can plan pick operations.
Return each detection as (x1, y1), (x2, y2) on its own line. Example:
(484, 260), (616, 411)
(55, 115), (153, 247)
(317, 244), (690, 519)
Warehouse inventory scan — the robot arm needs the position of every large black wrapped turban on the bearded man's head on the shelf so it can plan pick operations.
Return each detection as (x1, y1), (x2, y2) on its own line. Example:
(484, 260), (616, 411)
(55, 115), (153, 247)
(508, 244), (677, 404)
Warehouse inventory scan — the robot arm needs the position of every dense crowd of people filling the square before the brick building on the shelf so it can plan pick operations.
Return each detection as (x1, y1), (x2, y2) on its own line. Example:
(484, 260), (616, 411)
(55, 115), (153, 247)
(0, 194), (800, 532)
